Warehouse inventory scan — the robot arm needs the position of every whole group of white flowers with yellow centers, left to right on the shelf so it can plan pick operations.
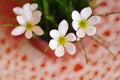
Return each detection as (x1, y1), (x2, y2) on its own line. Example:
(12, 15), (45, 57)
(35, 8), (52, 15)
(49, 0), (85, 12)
(11, 3), (100, 57)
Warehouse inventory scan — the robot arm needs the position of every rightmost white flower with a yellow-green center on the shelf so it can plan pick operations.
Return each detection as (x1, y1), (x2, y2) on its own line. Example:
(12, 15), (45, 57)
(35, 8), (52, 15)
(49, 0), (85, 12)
(72, 7), (100, 38)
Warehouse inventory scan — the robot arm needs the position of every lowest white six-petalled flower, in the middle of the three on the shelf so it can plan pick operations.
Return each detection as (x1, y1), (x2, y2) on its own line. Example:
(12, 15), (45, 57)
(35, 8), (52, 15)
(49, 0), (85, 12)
(49, 20), (76, 57)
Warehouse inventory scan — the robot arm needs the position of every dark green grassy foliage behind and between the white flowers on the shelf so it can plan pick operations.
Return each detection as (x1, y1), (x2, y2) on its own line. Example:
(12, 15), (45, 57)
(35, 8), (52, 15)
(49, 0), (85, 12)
(32, 0), (90, 41)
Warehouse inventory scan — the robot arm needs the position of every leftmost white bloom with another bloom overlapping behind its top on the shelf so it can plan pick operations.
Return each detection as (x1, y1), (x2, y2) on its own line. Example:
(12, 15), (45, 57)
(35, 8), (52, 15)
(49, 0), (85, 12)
(11, 3), (44, 39)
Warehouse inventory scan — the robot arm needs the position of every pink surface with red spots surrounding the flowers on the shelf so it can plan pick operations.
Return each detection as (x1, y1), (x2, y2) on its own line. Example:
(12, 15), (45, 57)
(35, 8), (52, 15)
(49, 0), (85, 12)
(0, 0), (120, 80)
